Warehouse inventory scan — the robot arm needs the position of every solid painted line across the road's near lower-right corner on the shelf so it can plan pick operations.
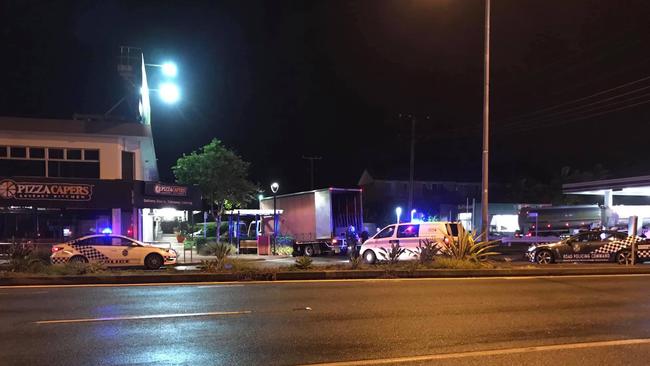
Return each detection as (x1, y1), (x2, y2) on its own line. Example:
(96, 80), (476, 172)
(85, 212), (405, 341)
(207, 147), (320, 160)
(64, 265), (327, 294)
(302, 338), (650, 366)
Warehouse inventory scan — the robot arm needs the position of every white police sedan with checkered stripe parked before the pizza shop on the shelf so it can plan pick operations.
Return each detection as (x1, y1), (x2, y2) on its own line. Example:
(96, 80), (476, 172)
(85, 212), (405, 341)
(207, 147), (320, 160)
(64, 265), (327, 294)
(50, 235), (177, 269)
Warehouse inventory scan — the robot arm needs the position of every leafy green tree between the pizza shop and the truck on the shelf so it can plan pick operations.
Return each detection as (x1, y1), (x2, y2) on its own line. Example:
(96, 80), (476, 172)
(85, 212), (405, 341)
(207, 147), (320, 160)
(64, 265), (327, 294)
(172, 139), (257, 242)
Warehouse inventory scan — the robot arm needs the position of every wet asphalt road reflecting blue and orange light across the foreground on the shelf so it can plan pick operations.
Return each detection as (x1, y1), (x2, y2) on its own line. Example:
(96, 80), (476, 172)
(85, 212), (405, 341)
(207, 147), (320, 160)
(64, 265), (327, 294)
(0, 275), (650, 366)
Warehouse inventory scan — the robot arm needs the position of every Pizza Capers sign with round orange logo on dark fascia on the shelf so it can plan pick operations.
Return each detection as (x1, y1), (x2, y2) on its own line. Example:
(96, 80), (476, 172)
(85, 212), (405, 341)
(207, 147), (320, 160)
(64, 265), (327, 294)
(0, 179), (93, 201)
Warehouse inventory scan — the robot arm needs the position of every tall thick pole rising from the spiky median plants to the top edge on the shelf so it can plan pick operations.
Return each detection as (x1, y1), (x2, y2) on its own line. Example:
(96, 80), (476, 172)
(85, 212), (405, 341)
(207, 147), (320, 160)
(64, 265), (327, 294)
(481, 0), (490, 240)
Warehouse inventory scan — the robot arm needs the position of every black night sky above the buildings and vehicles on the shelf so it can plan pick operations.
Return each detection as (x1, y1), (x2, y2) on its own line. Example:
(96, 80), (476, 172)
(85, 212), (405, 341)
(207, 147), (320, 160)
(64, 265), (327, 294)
(0, 0), (650, 191)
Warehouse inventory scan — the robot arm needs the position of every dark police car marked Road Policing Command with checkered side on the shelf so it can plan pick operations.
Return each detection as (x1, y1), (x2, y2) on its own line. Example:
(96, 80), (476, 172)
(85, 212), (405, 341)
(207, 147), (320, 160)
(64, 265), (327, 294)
(526, 230), (650, 264)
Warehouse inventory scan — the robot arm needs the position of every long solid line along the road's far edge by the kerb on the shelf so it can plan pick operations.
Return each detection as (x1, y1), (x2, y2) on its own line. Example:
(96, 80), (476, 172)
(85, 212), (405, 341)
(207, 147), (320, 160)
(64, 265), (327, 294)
(0, 273), (650, 290)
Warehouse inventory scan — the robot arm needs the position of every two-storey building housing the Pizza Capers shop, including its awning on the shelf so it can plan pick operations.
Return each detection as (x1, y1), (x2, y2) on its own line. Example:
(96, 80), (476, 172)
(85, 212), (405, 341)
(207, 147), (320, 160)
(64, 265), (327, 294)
(0, 117), (201, 242)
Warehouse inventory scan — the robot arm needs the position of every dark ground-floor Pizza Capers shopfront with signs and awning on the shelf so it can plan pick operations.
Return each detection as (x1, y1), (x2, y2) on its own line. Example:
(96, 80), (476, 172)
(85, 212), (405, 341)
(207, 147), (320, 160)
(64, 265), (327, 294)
(0, 177), (201, 242)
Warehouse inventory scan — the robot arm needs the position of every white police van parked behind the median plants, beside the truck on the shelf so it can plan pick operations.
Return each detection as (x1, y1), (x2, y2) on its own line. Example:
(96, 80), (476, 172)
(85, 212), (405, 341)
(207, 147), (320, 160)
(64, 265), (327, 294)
(359, 222), (461, 263)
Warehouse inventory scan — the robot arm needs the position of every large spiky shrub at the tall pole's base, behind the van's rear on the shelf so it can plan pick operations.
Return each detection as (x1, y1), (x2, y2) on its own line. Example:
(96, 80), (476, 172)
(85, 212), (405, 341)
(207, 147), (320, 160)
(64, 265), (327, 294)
(438, 225), (499, 262)
